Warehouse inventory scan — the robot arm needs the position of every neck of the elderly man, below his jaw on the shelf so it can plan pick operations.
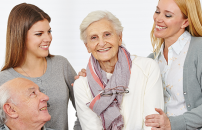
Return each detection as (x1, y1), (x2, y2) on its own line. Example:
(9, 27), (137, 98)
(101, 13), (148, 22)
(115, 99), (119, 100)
(6, 120), (45, 130)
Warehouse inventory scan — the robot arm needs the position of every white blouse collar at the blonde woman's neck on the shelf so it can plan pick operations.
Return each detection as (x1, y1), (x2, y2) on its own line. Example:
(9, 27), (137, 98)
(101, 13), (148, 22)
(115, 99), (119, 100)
(156, 31), (191, 58)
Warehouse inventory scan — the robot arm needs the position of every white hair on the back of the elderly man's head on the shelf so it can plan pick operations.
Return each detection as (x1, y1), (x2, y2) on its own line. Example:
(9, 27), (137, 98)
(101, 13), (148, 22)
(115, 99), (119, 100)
(0, 85), (11, 124)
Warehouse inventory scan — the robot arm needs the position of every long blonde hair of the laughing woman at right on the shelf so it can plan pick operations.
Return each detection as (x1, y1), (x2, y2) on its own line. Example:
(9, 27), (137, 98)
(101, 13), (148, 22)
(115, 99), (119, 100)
(150, 0), (202, 56)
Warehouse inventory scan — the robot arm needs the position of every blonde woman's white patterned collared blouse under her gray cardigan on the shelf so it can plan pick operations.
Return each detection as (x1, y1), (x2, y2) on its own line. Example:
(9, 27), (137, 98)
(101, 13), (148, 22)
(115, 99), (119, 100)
(156, 31), (191, 116)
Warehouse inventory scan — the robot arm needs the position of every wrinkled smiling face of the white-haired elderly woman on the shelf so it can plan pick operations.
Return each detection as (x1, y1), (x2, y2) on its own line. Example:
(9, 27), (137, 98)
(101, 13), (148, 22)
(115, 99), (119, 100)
(85, 19), (122, 62)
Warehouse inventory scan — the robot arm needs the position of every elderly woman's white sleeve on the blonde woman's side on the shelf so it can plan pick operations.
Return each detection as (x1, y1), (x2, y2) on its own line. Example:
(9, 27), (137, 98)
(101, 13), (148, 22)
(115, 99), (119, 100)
(143, 60), (164, 130)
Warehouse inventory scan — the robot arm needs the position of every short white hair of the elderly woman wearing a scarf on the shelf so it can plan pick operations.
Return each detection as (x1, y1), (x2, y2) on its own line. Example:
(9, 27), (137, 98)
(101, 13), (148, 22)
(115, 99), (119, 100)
(80, 10), (123, 43)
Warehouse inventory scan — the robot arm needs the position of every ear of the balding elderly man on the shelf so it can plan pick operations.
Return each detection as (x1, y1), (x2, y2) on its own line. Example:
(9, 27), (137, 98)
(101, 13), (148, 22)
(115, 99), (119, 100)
(3, 103), (18, 118)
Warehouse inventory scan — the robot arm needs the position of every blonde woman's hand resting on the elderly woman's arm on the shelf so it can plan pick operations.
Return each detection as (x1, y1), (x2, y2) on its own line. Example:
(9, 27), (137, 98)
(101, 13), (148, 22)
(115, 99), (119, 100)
(145, 108), (171, 130)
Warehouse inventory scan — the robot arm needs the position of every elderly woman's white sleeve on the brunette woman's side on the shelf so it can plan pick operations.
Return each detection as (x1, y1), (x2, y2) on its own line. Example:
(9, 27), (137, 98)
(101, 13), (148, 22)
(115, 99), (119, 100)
(74, 77), (102, 130)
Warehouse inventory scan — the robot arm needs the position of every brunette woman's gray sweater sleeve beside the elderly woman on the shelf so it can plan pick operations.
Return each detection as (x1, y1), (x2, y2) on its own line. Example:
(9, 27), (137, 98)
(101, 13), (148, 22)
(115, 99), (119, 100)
(64, 59), (82, 130)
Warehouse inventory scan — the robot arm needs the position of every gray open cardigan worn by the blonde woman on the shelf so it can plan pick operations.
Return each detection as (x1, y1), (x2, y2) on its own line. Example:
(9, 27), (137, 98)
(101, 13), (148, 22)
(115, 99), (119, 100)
(148, 37), (202, 130)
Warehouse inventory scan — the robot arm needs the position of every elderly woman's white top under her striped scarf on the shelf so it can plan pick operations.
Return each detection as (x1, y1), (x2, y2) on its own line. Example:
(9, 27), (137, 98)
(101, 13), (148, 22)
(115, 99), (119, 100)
(73, 57), (164, 130)
